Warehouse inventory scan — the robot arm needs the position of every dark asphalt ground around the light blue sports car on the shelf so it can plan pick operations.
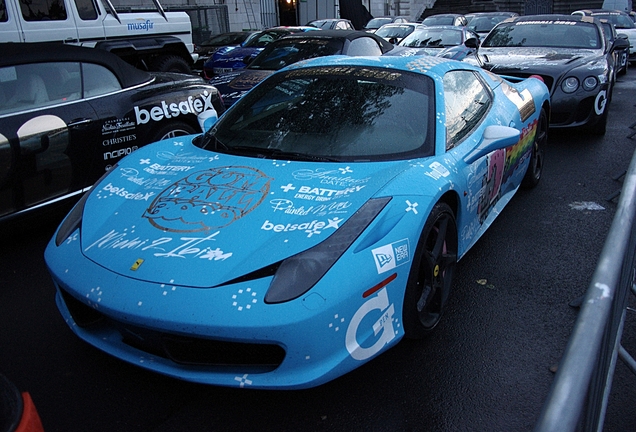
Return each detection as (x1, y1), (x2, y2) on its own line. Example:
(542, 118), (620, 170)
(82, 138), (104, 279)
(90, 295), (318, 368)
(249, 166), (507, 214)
(0, 68), (636, 432)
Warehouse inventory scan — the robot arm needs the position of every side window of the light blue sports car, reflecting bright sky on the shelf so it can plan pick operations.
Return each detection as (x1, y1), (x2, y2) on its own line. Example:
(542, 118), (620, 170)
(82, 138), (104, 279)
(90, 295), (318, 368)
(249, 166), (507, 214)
(444, 71), (492, 150)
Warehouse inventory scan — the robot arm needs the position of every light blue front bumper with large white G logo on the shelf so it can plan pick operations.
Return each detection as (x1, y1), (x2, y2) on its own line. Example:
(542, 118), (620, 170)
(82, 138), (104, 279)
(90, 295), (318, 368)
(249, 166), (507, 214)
(45, 230), (407, 389)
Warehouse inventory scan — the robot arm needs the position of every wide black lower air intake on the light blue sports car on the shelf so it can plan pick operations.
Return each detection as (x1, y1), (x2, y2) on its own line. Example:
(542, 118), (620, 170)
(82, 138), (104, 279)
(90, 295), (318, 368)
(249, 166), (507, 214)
(60, 290), (285, 372)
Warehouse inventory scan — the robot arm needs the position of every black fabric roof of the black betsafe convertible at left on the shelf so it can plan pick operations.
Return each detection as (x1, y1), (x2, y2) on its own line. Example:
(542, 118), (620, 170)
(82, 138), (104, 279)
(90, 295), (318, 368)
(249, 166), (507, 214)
(0, 42), (152, 87)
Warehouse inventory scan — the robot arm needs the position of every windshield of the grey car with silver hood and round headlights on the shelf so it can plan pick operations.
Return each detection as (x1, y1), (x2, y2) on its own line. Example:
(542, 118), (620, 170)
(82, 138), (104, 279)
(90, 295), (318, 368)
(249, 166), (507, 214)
(481, 20), (602, 49)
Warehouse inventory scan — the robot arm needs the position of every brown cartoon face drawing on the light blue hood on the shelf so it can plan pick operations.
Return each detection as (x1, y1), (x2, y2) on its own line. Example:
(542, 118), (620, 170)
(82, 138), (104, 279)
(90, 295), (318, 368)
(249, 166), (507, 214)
(143, 166), (273, 232)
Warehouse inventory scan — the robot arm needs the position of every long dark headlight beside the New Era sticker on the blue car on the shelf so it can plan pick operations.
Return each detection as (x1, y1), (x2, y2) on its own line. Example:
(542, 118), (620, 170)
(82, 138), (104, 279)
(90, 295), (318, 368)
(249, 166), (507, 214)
(265, 198), (391, 303)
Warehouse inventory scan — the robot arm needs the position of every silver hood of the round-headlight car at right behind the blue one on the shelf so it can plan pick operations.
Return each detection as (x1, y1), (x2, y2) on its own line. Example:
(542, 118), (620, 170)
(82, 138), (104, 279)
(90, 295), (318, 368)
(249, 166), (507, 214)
(478, 47), (603, 76)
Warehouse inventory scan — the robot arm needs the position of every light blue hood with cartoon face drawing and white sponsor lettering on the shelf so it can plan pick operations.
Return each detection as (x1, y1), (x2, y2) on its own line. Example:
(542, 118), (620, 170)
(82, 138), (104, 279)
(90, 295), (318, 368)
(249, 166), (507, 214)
(81, 136), (408, 287)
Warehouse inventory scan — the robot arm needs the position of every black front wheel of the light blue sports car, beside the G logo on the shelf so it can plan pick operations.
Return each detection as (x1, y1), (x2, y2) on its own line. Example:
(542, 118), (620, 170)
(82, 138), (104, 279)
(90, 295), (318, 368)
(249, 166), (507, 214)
(402, 202), (457, 339)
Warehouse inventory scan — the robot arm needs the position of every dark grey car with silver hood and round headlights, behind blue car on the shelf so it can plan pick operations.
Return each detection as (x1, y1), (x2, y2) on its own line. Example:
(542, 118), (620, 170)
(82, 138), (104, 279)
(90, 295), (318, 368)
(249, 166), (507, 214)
(464, 15), (627, 134)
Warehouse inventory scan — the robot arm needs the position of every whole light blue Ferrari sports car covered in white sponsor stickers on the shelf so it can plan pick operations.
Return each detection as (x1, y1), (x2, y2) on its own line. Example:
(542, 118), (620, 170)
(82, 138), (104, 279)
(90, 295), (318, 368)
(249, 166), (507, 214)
(45, 56), (550, 388)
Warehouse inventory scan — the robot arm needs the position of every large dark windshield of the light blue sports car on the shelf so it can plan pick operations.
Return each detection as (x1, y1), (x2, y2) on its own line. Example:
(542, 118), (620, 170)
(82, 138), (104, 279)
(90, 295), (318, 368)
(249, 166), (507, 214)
(200, 66), (436, 161)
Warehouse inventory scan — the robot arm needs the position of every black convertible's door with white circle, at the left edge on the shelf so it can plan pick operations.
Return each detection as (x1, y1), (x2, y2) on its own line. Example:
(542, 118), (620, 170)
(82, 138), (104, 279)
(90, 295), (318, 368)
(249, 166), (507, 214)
(0, 62), (98, 218)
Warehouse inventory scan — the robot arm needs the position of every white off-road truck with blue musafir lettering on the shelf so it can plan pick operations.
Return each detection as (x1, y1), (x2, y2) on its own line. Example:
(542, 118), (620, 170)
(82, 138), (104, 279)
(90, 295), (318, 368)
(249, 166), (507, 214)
(0, 0), (198, 73)
